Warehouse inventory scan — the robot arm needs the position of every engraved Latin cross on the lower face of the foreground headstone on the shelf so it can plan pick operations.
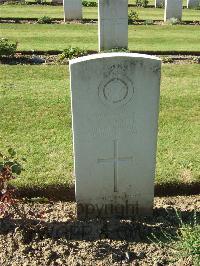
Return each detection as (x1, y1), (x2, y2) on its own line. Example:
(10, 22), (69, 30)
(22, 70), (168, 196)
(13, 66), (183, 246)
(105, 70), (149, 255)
(98, 140), (133, 192)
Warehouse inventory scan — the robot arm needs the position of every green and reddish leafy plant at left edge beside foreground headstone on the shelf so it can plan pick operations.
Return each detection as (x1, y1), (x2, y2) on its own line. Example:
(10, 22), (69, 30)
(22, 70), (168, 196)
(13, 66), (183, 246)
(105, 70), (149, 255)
(0, 148), (26, 217)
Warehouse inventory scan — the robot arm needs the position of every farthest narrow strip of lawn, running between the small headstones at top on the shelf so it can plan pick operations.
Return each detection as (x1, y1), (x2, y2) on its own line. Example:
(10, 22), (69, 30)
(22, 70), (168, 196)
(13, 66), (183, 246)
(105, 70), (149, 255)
(0, 5), (200, 21)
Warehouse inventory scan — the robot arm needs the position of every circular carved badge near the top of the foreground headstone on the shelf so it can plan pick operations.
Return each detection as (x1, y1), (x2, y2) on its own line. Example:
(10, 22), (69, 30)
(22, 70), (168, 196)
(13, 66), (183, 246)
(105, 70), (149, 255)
(99, 75), (134, 107)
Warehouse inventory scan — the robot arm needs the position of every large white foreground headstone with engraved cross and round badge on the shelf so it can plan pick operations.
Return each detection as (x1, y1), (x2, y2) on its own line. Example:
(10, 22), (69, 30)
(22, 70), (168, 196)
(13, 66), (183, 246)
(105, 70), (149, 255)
(70, 53), (161, 218)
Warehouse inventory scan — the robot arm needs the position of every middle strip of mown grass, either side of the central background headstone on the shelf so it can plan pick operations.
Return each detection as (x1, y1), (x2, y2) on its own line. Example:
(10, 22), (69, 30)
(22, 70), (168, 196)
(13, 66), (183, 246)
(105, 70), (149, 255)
(1, 24), (200, 51)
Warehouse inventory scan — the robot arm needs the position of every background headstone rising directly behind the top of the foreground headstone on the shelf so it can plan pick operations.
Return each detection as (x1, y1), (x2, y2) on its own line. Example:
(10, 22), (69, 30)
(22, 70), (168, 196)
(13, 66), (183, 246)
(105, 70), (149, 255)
(98, 0), (128, 51)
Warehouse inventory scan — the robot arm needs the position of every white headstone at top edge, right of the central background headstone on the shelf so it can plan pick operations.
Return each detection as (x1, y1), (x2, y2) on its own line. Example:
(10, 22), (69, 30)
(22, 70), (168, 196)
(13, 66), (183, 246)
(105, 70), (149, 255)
(164, 0), (182, 21)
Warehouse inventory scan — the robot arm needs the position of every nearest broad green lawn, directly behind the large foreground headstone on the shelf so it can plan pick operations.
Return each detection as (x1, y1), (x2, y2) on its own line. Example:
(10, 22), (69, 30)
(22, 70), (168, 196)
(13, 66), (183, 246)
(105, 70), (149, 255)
(0, 65), (200, 187)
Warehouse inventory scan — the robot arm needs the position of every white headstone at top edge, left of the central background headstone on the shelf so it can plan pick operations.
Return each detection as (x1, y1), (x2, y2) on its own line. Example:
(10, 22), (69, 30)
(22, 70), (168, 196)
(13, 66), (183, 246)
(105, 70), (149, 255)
(63, 0), (82, 21)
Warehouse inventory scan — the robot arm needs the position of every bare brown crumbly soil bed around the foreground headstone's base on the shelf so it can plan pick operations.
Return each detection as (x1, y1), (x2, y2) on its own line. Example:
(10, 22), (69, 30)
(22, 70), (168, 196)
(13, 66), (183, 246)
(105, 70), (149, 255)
(0, 195), (200, 266)
